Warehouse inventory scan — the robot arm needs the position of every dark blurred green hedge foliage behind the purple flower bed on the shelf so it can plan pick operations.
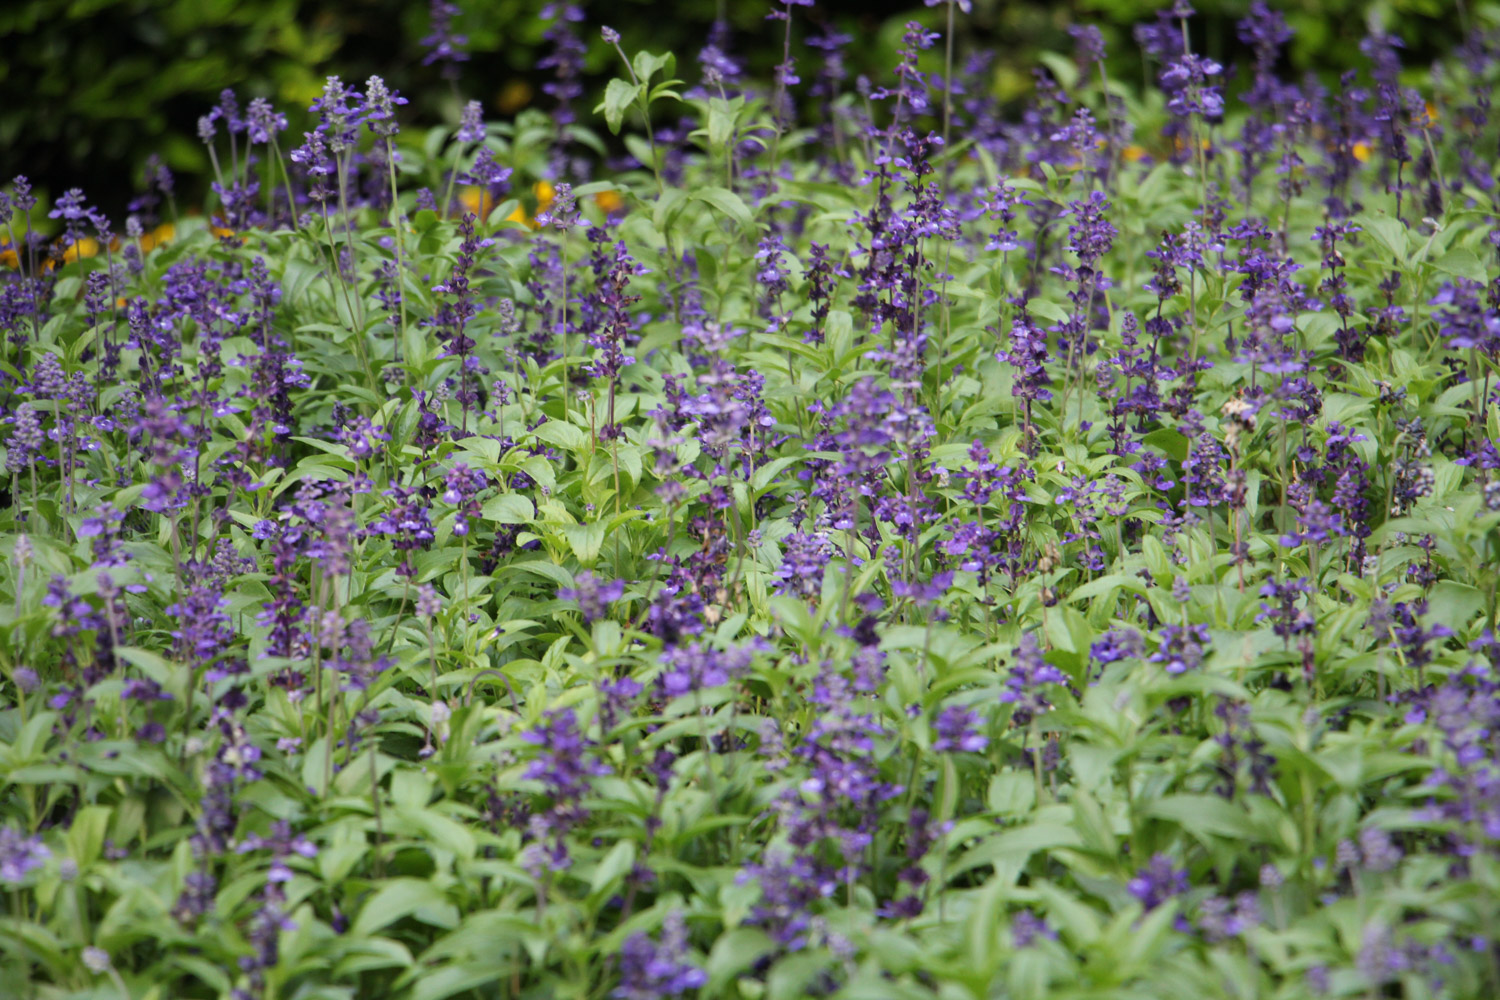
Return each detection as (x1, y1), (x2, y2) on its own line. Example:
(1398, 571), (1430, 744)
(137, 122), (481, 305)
(0, 0), (1467, 216)
